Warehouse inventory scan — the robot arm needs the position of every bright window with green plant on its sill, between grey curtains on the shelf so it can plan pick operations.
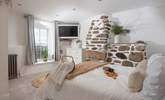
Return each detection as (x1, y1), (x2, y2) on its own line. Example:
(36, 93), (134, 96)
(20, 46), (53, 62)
(34, 20), (55, 63)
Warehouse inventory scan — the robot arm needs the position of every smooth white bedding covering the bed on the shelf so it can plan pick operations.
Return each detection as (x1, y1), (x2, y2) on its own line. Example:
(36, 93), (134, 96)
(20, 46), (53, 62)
(36, 65), (143, 100)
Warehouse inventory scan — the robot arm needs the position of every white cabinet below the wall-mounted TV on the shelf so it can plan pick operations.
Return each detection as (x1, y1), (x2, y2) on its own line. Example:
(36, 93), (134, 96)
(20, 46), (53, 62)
(66, 47), (82, 64)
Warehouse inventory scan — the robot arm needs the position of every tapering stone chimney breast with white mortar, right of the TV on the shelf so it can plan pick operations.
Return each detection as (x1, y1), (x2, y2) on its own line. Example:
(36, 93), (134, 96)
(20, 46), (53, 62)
(86, 16), (111, 51)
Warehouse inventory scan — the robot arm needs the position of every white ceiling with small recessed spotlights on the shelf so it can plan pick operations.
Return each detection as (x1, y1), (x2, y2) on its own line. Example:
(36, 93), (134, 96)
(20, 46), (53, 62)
(13, 0), (165, 22)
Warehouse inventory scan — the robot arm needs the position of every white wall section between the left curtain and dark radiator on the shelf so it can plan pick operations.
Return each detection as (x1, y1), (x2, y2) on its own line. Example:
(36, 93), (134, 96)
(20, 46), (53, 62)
(8, 9), (27, 72)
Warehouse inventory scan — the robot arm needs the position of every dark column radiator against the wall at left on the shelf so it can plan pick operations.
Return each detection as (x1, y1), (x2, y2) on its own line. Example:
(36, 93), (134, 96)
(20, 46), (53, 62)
(8, 54), (18, 80)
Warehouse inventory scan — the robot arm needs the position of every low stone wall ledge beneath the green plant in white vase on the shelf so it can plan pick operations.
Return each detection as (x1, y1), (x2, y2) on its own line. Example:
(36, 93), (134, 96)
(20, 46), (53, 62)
(107, 43), (146, 67)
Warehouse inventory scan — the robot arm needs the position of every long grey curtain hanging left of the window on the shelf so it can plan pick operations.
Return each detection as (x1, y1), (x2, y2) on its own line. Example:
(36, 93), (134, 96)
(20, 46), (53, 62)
(25, 15), (37, 65)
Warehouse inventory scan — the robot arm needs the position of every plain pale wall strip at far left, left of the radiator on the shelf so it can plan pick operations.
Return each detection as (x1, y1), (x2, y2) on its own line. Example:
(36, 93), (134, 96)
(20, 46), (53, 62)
(0, 4), (9, 100)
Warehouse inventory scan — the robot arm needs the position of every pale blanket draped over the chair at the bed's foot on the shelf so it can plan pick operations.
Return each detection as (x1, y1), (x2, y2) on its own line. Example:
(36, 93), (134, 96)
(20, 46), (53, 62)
(48, 62), (74, 90)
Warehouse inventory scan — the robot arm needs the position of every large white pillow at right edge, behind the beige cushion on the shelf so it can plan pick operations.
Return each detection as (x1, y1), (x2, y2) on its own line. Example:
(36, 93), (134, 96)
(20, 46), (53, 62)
(141, 54), (165, 100)
